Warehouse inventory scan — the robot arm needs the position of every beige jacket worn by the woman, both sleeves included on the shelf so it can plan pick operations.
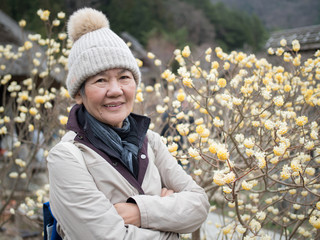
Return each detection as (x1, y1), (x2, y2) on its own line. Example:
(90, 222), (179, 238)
(47, 130), (209, 240)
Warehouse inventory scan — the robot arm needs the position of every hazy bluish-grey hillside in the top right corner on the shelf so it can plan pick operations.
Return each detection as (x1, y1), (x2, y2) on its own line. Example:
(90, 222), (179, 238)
(211, 0), (320, 30)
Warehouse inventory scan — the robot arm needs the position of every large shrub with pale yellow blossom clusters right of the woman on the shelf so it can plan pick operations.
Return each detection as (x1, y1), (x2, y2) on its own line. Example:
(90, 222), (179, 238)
(135, 44), (320, 239)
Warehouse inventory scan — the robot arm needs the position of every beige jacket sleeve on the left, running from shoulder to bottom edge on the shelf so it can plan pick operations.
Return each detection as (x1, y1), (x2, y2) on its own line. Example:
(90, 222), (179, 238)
(47, 142), (178, 240)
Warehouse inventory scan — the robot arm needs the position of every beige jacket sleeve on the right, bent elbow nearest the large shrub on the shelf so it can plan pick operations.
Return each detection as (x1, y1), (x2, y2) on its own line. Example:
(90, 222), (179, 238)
(132, 131), (209, 233)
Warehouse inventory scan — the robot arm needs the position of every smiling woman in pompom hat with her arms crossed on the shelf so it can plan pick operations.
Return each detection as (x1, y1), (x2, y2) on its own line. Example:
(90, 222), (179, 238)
(47, 8), (209, 240)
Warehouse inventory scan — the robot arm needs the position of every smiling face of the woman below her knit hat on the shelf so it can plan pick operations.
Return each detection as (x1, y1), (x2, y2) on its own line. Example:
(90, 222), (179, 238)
(76, 68), (136, 128)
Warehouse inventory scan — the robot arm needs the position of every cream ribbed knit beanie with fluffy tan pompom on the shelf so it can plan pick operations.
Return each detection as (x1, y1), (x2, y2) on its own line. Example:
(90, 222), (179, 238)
(66, 8), (141, 98)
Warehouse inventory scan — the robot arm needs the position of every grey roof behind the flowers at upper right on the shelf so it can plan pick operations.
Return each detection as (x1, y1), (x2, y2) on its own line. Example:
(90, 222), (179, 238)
(266, 25), (320, 51)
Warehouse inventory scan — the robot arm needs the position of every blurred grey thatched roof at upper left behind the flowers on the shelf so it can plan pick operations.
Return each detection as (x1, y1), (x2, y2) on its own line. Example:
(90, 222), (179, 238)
(0, 10), (65, 82)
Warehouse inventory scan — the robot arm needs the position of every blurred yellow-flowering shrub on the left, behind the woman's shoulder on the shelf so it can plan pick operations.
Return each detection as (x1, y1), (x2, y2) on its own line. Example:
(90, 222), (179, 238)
(0, 10), (71, 230)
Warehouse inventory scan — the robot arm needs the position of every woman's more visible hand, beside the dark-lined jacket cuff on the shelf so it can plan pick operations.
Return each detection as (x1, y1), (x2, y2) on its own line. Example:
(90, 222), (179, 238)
(114, 203), (141, 227)
